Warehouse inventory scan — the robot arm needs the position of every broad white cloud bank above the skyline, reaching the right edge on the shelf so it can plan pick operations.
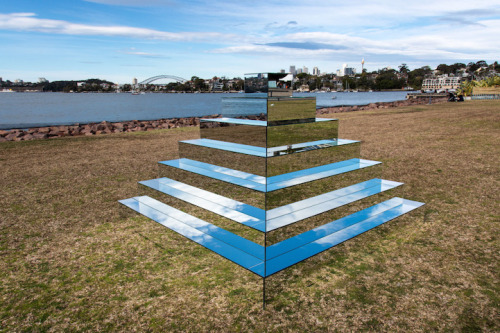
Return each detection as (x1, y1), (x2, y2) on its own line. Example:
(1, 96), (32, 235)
(212, 20), (500, 61)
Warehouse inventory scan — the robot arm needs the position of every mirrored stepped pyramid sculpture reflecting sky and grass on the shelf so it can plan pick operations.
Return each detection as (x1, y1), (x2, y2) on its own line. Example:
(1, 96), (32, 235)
(120, 73), (423, 304)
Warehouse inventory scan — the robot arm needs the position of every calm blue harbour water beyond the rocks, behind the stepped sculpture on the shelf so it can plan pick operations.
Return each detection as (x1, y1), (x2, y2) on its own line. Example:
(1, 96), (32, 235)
(0, 91), (407, 129)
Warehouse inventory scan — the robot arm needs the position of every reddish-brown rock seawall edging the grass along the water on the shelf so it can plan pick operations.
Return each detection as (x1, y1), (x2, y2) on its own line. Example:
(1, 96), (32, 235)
(0, 98), (446, 142)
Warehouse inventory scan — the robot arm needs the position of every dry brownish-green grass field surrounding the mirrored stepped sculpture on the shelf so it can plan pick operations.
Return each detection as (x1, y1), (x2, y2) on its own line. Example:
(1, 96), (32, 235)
(0, 101), (500, 332)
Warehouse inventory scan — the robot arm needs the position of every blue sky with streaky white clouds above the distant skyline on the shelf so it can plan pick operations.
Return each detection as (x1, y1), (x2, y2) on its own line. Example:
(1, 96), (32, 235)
(0, 0), (500, 83)
